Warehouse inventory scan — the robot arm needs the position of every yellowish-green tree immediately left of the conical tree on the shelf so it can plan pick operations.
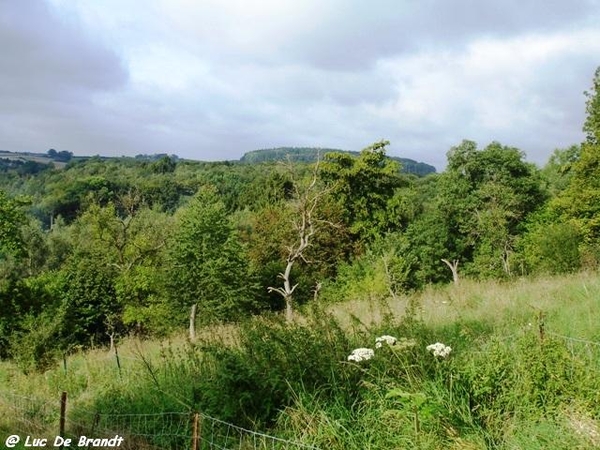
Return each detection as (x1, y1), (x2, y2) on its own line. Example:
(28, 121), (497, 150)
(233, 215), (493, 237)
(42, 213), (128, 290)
(75, 191), (173, 339)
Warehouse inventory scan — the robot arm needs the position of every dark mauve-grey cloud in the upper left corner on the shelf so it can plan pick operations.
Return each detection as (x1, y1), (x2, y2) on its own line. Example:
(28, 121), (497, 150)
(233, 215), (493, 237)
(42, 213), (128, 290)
(0, 1), (127, 98)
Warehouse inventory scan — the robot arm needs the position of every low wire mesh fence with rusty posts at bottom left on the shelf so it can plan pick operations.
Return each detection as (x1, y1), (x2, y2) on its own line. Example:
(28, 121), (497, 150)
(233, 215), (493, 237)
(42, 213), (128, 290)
(0, 392), (318, 450)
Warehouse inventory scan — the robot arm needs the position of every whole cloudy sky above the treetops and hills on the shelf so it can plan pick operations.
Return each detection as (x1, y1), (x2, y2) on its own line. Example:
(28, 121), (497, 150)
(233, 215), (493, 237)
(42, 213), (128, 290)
(0, 0), (600, 169)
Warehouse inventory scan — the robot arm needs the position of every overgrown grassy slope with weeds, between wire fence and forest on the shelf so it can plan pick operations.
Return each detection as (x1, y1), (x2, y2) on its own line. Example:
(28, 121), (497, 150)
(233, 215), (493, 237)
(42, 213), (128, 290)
(0, 273), (600, 450)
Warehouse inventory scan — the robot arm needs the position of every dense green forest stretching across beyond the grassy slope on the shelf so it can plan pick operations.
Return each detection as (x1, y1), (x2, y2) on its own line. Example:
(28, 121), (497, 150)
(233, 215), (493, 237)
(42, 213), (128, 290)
(0, 68), (600, 448)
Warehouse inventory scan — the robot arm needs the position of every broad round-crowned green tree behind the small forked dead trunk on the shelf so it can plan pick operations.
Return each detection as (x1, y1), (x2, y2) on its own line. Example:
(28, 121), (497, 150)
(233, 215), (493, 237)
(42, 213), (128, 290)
(422, 141), (544, 280)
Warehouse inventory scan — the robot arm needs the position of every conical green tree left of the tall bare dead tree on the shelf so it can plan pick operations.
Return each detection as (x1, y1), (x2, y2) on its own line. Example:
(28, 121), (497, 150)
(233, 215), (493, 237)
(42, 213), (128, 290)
(167, 186), (254, 339)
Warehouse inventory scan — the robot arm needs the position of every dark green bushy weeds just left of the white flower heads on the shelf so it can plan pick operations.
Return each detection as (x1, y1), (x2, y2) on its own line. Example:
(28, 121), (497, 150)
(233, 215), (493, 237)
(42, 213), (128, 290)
(190, 311), (358, 427)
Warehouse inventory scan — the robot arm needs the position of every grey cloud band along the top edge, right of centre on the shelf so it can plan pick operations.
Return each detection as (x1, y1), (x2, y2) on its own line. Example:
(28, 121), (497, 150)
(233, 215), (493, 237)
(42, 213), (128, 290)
(258, 0), (598, 70)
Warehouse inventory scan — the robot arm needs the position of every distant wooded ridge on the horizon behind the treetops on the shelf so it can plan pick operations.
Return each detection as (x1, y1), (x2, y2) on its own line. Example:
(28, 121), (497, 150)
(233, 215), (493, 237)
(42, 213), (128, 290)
(240, 147), (435, 176)
